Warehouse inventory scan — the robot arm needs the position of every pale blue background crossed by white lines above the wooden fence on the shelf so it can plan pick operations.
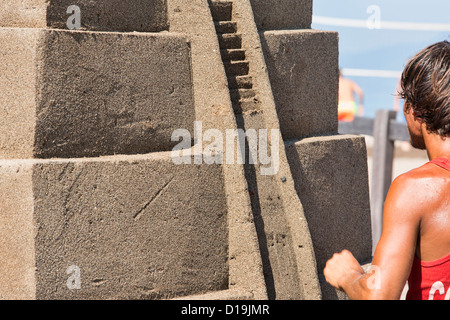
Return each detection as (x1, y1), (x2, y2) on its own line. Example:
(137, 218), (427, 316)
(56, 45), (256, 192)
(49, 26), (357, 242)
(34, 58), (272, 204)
(312, 0), (450, 117)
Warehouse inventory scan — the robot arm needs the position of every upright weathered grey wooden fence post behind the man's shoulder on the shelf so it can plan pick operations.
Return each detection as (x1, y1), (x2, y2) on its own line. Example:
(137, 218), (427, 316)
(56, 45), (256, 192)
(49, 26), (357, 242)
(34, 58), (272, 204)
(370, 110), (397, 250)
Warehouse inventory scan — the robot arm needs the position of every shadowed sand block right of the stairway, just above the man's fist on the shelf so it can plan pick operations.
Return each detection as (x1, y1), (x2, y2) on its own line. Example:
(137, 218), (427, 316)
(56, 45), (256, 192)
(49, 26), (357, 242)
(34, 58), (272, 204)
(286, 135), (372, 299)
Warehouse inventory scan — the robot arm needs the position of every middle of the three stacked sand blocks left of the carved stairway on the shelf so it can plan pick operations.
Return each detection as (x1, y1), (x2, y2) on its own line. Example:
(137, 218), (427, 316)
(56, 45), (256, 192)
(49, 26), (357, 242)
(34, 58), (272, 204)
(0, 28), (195, 158)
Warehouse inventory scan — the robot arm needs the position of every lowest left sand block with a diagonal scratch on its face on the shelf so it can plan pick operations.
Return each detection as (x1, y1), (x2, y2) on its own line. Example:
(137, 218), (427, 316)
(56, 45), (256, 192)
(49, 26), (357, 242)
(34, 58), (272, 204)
(0, 152), (228, 299)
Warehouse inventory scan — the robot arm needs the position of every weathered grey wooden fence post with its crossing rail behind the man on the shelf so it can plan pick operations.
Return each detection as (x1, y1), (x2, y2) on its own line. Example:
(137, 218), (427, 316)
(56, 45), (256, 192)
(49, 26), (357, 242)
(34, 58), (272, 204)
(339, 110), (409, 248)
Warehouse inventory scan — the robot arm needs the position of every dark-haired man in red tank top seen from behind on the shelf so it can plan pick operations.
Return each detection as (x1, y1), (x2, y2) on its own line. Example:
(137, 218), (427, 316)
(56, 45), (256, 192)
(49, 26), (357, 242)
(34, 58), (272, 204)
(324, 41), (450, 300)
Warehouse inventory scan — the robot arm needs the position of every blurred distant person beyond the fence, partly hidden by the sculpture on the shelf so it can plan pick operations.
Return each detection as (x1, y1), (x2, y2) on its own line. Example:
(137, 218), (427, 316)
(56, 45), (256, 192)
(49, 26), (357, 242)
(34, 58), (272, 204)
(338, 71), (364, 122)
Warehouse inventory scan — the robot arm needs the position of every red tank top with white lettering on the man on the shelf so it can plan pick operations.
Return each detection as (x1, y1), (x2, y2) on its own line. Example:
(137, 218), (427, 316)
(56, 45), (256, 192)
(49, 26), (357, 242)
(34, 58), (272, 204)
(406, 158), (450, 300)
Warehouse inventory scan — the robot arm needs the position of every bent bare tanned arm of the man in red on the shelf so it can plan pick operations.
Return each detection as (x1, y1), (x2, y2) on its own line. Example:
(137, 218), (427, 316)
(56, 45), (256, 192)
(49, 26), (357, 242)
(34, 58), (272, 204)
(324, 174), (421, 300)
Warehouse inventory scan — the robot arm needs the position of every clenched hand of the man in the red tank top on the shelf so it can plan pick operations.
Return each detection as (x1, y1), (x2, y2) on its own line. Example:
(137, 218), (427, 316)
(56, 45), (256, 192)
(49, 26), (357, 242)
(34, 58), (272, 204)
(323, 250), (364, 291)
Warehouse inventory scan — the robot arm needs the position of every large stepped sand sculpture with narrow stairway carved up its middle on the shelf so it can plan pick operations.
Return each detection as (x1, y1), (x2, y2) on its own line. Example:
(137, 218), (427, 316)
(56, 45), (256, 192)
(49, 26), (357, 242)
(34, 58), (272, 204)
(0, 0), (372, 299)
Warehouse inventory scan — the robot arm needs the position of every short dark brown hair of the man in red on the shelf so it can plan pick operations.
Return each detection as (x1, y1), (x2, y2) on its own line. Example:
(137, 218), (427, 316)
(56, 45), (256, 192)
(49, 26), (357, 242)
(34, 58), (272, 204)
(400, 41), (450, 137)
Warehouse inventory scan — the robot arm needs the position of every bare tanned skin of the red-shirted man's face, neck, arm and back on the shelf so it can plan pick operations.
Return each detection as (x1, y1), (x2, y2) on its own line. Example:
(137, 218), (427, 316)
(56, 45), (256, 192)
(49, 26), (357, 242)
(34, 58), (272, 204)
(324, 104), (450, 300)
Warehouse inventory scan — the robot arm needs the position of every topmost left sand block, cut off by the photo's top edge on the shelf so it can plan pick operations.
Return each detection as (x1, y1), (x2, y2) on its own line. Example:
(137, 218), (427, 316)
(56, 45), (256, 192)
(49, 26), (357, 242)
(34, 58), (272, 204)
(0, 0), (169, 32)
